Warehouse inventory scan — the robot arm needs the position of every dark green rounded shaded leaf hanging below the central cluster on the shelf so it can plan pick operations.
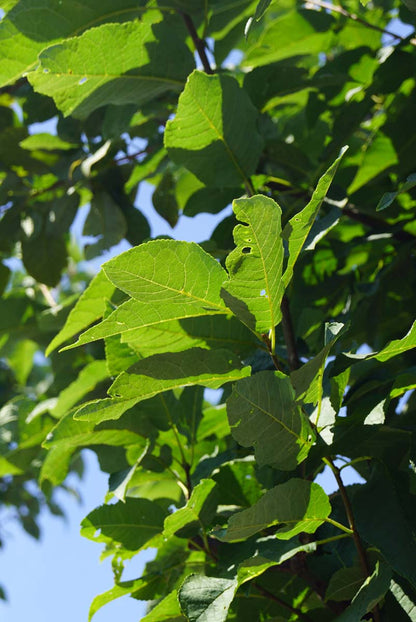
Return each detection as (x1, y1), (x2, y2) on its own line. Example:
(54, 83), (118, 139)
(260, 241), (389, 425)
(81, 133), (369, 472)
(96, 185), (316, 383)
(227, 371), (314, 471)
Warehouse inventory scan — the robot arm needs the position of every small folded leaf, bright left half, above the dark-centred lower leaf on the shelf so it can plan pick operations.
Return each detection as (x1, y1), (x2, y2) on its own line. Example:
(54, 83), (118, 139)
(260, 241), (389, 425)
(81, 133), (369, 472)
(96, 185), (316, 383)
(163, 479), (217, 538)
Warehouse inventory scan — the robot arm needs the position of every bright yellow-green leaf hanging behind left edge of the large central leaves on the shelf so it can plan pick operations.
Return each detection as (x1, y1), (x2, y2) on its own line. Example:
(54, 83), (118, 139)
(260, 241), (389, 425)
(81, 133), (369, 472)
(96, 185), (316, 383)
(45, 272), (115, 356)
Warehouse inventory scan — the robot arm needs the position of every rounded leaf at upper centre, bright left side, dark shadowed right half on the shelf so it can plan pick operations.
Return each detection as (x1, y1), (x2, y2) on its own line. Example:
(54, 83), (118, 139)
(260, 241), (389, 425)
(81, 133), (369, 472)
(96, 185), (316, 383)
(165, 71), (263, 187)
